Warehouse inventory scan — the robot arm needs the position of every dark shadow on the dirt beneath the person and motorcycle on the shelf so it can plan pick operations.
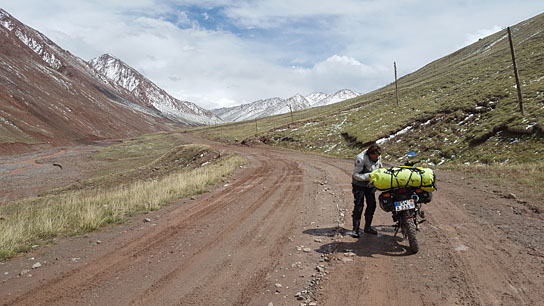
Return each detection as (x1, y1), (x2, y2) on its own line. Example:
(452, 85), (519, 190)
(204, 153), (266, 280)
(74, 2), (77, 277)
(303, 225), (412, 257)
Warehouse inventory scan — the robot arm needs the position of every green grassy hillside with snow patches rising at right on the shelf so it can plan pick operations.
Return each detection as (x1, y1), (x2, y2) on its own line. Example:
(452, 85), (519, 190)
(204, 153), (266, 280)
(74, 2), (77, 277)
(199, 14), (544, 165)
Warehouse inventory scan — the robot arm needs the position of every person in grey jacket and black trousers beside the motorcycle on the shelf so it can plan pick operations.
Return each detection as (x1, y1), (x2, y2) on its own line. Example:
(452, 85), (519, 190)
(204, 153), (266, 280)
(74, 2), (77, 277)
(351, 143), (382, 238)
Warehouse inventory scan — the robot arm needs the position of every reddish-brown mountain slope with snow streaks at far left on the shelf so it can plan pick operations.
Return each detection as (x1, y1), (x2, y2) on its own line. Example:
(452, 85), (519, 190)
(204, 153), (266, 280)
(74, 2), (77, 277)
(0, 9), (205, 151)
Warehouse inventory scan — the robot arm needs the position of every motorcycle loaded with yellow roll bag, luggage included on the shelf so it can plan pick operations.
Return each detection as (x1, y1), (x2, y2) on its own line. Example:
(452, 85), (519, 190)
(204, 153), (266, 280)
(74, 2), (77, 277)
(370, 152), (436, 253)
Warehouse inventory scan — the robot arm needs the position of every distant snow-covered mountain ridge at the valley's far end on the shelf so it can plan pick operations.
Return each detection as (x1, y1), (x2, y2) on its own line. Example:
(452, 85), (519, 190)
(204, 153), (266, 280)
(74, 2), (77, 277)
(211, 89), (360, 122)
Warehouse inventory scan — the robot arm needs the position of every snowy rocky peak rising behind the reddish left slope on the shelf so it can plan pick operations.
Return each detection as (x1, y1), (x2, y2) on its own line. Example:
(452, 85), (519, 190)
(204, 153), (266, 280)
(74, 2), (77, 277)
(89, 54), (222, 125)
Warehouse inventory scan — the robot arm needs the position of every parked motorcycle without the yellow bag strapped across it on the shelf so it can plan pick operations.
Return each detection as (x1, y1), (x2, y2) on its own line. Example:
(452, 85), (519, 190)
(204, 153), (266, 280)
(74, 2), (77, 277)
(378, 152), (434, 254)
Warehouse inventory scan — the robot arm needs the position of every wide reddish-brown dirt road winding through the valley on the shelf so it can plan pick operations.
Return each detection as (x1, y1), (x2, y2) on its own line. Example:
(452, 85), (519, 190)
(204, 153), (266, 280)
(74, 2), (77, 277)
(0, 137), (544, 305)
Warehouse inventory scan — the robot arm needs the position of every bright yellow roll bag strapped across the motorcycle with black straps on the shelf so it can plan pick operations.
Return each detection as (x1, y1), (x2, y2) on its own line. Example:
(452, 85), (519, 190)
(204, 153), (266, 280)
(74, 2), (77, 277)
(370, 167), (436, 192)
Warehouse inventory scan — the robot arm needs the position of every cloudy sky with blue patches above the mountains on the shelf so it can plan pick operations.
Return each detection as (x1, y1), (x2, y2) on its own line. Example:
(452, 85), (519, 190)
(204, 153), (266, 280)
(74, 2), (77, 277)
(0, 0), (544, 109)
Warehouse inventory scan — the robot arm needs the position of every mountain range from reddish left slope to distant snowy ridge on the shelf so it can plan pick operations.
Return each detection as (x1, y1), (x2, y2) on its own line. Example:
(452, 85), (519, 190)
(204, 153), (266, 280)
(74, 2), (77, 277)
(0, 9), (366, 153)
